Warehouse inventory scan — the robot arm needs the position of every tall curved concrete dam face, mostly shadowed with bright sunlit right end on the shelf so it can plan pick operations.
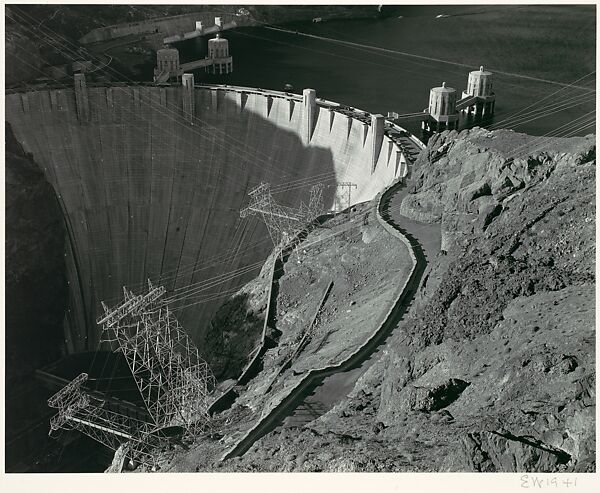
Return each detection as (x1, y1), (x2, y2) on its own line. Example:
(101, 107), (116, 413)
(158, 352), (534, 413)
(6, 79), (406, 352)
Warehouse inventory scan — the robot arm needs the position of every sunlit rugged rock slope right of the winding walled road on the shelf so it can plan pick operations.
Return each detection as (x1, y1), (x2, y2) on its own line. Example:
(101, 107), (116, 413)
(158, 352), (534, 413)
(214, 129), (595, 472)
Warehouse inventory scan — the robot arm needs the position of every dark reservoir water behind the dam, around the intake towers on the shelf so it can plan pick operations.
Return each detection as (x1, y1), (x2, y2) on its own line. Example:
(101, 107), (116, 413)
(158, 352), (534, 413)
(177, 5), (595, 135)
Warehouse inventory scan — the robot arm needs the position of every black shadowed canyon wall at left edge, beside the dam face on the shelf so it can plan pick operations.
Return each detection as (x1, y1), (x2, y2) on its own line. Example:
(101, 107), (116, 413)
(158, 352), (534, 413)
(4, 125), (67, 380)
